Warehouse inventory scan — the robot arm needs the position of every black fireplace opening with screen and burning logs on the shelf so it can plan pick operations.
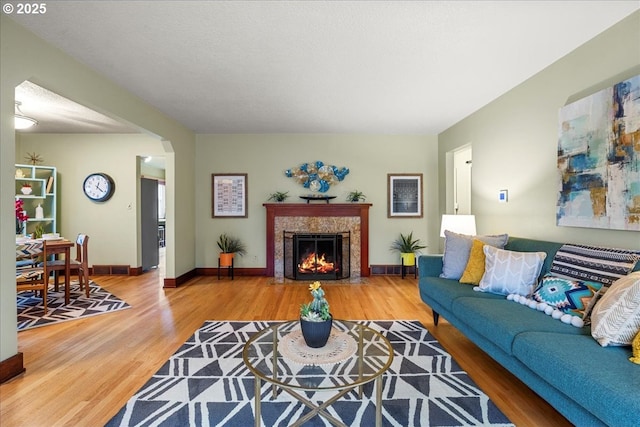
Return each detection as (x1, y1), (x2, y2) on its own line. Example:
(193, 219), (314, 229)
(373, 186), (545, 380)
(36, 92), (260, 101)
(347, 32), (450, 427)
(283, 231), (351, 280)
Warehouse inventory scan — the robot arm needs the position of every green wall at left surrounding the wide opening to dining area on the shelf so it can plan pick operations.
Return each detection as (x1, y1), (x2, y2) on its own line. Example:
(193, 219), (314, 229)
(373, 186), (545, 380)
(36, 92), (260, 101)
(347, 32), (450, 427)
(0, 15), (195, 360)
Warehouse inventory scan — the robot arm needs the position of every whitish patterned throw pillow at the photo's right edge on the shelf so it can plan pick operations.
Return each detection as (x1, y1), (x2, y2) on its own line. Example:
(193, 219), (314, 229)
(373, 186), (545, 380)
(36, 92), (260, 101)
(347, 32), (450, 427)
(591, 271), (640, 347)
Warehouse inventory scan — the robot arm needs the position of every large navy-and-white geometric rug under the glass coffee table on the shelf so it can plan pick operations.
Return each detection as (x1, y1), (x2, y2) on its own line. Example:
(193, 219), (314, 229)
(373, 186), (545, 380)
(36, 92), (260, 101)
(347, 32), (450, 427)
(107, 321), (512, 427)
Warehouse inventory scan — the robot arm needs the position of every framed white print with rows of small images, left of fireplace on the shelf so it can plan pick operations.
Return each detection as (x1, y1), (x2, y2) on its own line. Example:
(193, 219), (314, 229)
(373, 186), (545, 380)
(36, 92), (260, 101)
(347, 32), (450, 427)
(211, 173), (247, 218)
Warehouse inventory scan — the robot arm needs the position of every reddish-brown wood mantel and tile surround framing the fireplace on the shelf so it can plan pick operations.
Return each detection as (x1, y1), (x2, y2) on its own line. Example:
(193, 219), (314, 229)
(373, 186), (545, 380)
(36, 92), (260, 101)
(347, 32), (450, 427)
(263, 203), (371, 282)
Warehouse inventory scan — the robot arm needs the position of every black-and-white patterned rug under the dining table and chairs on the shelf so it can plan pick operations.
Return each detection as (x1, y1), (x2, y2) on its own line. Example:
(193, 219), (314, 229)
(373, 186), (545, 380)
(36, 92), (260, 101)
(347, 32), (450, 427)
(18, 281), (130, 331)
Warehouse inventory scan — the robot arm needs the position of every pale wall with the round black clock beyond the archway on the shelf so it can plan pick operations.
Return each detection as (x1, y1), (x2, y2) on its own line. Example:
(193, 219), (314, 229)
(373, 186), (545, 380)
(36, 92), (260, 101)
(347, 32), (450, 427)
(16, 133), (164, 267)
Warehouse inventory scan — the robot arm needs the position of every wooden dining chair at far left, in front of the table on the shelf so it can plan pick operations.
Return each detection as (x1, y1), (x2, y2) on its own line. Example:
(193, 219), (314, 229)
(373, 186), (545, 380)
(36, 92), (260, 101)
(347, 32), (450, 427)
(16, 242), (49, 314)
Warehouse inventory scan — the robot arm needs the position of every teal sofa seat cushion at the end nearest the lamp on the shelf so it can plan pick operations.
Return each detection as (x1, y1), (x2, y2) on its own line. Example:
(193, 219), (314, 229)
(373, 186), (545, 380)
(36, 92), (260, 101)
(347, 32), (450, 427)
(451, 296), (591, 354)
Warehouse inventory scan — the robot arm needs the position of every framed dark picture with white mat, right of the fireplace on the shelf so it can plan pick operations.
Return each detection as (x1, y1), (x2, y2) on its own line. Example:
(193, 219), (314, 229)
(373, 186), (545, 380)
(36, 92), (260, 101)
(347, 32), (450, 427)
(387, 173), (422, 218)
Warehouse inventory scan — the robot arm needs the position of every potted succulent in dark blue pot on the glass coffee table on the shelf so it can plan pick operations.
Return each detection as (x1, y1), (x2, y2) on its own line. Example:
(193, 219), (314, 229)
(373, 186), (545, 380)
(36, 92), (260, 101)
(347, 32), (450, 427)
(300, 282), (333, 348)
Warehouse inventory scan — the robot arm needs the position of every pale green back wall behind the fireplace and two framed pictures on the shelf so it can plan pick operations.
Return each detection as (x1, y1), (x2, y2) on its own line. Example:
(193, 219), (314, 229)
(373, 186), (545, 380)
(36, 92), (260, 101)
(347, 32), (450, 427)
(196, 134), (440, 267)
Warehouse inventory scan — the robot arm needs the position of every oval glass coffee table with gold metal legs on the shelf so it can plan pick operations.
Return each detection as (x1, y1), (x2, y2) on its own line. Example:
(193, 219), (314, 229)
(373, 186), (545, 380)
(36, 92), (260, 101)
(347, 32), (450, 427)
(242, 319), (393, 426)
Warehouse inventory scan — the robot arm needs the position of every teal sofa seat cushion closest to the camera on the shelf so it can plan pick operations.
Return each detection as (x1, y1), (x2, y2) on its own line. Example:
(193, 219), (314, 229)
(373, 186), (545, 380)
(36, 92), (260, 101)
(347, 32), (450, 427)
(513, 332), (640, 426)
